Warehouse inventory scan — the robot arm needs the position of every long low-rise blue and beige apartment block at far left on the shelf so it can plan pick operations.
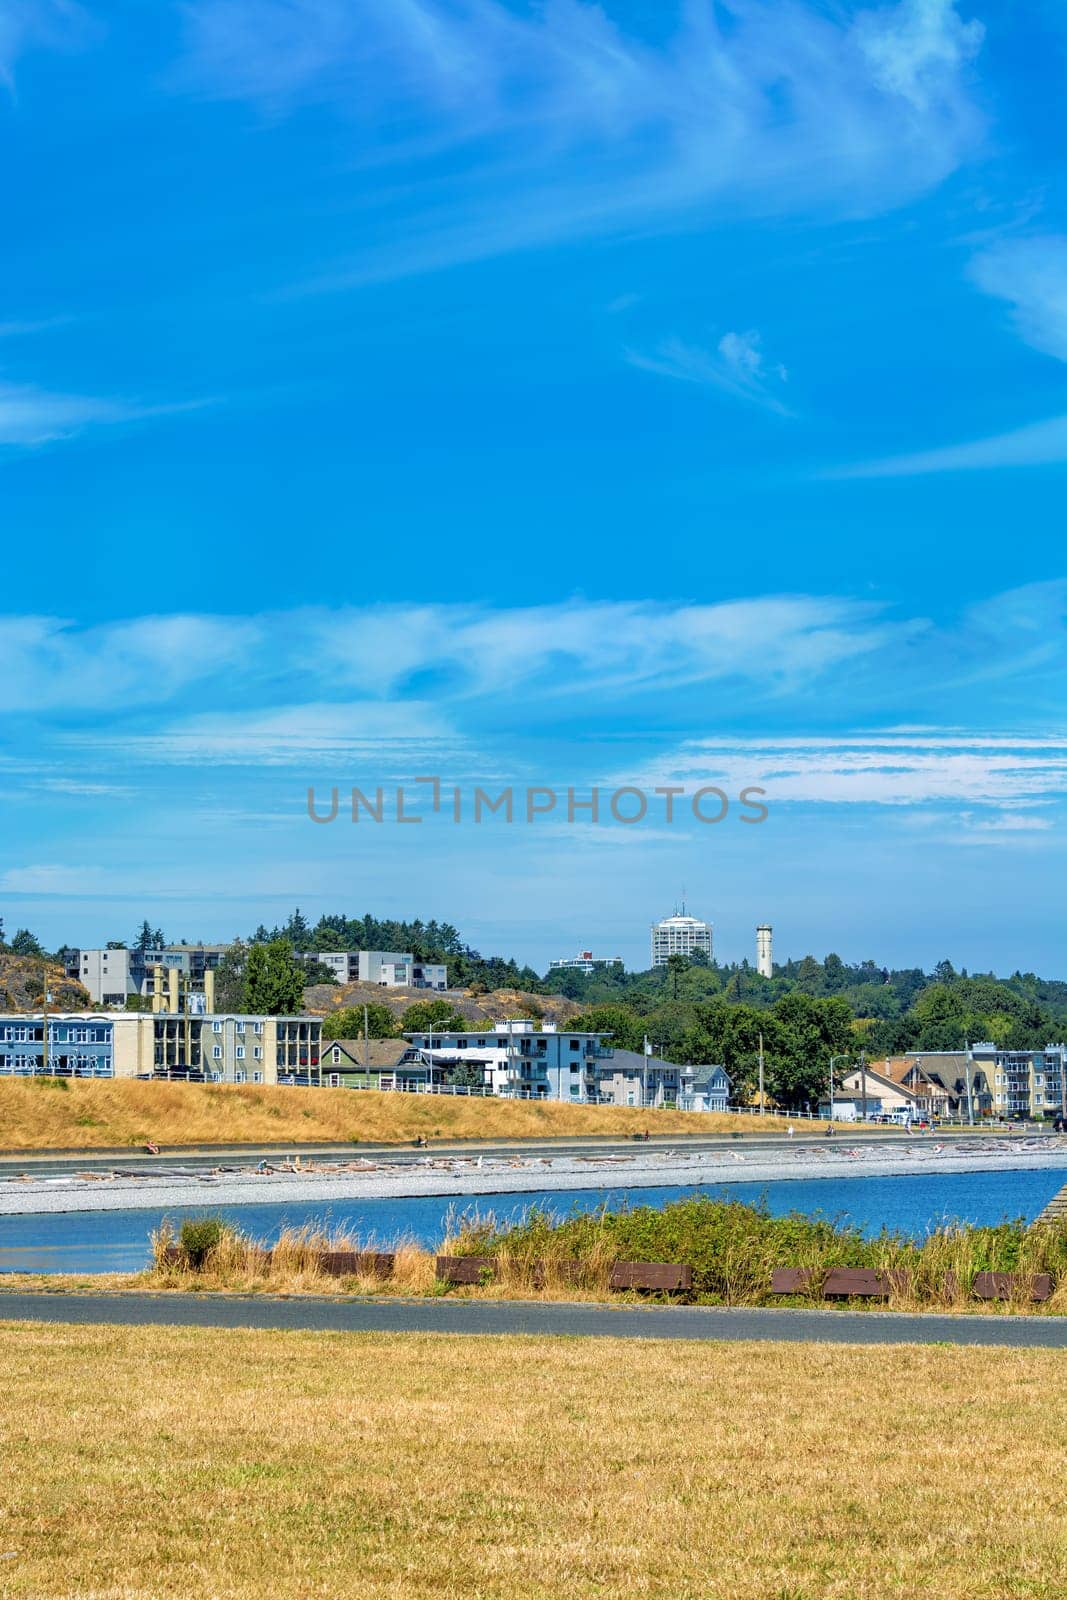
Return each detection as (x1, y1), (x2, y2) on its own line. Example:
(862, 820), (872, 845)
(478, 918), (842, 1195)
(0, 1011), (322, 1085)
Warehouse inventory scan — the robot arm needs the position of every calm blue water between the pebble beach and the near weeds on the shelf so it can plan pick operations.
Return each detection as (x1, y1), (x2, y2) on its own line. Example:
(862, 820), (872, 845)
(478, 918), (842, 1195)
(0, 1166), (1067, 1272)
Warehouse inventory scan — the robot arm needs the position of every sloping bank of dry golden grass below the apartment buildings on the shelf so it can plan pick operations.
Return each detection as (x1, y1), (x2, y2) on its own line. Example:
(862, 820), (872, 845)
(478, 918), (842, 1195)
(0, 1078), (782, 1150)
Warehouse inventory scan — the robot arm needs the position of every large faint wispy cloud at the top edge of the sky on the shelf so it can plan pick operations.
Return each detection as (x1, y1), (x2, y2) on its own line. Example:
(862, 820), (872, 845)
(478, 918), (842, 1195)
(181, 0), (982, 290)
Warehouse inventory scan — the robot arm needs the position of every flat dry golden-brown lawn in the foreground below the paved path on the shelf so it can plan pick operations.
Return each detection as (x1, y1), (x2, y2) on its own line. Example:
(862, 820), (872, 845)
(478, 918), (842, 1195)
(0, 1325), (1067, 1600)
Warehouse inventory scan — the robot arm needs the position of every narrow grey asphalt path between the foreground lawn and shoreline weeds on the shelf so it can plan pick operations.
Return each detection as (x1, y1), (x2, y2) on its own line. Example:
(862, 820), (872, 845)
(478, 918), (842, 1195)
(0, 1293), (1067, 1350)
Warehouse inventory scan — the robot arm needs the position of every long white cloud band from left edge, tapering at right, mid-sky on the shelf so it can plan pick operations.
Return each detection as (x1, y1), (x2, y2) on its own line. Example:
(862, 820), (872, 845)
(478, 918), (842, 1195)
(0, 595), (902, 712)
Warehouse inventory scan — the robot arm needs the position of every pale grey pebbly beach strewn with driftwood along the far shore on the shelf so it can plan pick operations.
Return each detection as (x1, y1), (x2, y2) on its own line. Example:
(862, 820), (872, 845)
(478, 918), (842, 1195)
(0, 1138), (1067, 1216)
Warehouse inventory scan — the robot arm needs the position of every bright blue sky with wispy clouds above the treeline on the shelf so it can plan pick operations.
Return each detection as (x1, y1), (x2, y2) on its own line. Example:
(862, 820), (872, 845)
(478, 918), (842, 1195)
(0, 0), (1067, 974)
